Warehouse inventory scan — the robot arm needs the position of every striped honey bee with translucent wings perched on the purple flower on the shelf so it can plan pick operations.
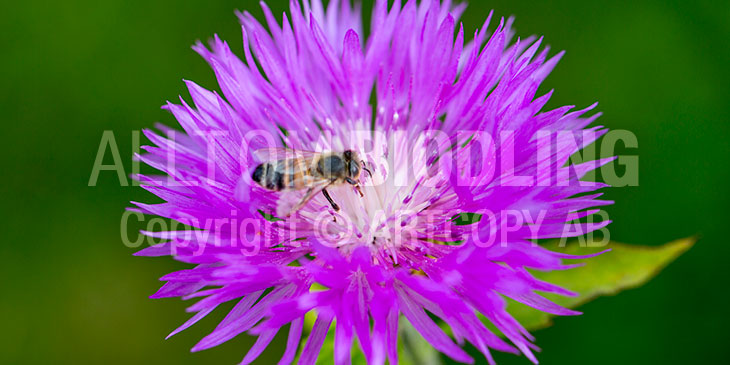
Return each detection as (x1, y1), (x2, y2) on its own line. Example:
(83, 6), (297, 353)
(251, 148), (370, 217)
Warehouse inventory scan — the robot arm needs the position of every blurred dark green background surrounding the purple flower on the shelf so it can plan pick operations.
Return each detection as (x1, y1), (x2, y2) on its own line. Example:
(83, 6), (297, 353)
(0, 0), (730, 364)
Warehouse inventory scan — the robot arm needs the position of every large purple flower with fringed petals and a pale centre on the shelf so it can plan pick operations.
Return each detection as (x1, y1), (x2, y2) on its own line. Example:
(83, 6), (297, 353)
(134, 0), (611, 364)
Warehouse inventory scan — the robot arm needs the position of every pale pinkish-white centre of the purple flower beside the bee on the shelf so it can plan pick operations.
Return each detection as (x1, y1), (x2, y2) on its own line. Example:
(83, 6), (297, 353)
(288, 115), (456, 263)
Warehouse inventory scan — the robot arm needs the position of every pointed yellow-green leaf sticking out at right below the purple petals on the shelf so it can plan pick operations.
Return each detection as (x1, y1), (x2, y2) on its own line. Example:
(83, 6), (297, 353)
(494, 237), (697, 330)
